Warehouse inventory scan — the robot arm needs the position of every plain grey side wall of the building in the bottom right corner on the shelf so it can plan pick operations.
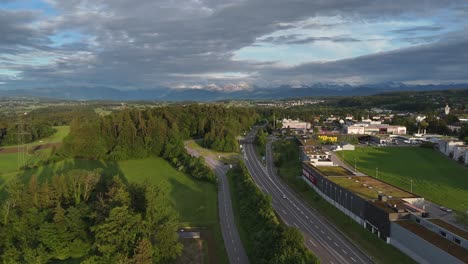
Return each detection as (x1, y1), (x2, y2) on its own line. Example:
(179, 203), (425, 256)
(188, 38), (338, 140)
(390, 222), (463, 264)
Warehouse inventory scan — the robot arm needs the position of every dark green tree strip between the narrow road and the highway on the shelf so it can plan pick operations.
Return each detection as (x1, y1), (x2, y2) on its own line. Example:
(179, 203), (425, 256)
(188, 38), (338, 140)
(229, 163), (319, 264)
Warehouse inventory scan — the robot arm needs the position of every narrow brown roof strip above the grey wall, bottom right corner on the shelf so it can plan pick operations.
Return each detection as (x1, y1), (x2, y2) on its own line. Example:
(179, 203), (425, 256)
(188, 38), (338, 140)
(395, 220), (468, 263)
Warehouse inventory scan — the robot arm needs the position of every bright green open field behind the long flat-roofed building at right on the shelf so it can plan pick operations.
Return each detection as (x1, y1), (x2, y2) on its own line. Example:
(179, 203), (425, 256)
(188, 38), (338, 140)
(340, 147), (468, 211)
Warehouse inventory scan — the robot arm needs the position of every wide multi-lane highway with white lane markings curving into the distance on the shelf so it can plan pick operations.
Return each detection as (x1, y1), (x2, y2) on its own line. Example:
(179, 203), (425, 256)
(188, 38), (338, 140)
(243, 130), (372, 264)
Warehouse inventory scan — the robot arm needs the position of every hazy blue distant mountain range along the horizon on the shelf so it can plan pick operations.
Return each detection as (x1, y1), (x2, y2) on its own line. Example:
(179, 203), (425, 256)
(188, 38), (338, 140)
(0, 83), (468, 101)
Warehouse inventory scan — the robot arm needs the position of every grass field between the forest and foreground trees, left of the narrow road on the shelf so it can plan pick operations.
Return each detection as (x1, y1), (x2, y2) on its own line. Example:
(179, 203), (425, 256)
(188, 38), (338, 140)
(0, 158), (227, 263)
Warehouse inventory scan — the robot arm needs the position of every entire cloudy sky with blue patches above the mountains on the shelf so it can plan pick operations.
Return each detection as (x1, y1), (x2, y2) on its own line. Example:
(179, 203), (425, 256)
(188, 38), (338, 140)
(0, 0), (468, 91)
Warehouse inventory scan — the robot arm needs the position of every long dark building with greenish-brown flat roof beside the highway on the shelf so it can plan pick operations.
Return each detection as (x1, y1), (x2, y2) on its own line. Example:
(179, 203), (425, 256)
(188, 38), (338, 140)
(302, 162), (425, 242)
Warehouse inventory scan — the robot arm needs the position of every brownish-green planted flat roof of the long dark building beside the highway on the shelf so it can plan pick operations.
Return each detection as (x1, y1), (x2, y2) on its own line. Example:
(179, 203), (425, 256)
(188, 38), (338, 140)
(328, 176), (416, 200)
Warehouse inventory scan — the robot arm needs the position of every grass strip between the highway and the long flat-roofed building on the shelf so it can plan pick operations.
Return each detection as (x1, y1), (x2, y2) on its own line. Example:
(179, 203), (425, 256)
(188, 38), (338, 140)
(273, 140), (414, 264)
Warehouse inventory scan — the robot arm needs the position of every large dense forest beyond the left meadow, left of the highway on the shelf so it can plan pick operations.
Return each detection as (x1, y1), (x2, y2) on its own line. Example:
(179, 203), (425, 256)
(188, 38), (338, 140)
(63, 105), (256, 181)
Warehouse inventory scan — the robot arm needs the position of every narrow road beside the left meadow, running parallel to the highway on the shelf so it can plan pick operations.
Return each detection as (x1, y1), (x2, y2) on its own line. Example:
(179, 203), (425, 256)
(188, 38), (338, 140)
(186, 147), (249, 264)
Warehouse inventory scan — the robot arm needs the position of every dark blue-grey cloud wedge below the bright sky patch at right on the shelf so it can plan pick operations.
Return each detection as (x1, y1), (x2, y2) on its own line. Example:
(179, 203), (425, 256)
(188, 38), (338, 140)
(262, 32), (468, 83)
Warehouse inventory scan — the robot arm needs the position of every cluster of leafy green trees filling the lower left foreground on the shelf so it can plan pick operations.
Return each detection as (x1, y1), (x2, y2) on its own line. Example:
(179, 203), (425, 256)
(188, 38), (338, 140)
(0, 170), (182, 264)
